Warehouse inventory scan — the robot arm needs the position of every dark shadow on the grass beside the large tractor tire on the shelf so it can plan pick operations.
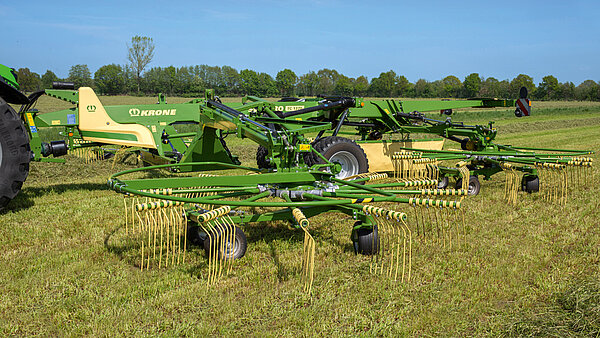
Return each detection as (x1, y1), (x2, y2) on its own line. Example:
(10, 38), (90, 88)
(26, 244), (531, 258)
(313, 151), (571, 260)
(0, 183), (108, 214)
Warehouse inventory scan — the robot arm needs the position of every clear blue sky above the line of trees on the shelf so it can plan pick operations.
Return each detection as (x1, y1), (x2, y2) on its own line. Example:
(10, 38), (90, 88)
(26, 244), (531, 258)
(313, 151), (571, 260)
(0, 0), (600, 85)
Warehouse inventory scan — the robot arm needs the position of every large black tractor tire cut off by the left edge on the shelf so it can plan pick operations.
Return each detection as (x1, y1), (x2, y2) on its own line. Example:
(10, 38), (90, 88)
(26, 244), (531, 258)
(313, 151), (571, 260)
(0, 99), (31, 211)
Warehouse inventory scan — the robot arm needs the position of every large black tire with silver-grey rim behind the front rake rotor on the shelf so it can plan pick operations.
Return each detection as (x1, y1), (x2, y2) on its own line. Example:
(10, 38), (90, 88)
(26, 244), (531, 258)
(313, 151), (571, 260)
(312, 136), (369, 179)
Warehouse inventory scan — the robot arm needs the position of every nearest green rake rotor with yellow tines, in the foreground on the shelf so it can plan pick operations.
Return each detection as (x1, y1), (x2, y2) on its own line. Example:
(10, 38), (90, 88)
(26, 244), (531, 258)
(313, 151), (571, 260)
(109, 162), (466, 292)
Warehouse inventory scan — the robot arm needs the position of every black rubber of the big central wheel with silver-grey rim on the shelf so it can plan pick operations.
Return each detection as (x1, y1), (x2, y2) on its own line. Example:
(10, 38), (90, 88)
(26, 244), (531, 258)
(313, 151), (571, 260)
(311, 136), (369, 179)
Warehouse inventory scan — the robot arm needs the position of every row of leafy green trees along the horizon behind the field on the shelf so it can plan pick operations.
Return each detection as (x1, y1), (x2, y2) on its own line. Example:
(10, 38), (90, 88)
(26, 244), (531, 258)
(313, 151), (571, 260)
(12, 64), (600, 101)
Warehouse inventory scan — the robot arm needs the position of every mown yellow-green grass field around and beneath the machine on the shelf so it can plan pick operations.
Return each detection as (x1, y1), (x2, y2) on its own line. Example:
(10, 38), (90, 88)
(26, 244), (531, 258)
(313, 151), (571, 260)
(0, 97), (600, 336)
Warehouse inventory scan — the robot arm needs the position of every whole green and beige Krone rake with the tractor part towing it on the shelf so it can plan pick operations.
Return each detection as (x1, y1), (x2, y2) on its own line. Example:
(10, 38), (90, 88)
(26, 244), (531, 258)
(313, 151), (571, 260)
(0, 63), (592, 290)
